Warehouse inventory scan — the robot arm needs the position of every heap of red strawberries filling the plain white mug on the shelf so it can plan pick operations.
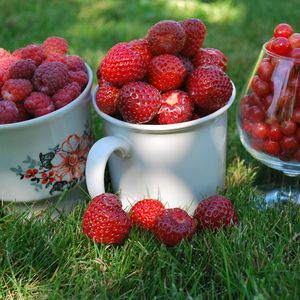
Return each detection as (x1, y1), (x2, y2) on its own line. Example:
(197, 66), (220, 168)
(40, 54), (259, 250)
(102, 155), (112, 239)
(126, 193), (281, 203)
(96, 19), (233, 124)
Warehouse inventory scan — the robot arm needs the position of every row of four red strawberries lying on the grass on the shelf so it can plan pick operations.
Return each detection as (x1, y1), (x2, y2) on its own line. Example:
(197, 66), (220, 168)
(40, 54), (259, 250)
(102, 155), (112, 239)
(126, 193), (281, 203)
(82, 193), (238, 246)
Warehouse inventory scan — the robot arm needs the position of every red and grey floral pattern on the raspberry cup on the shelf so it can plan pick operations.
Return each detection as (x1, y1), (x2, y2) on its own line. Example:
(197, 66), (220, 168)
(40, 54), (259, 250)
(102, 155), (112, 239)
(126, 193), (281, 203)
(10, 124), (92, 195)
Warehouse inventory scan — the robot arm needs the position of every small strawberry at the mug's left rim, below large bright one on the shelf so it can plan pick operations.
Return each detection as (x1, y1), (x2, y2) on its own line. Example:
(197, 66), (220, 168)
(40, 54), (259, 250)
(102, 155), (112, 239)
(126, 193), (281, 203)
(96, 83), (120, 115)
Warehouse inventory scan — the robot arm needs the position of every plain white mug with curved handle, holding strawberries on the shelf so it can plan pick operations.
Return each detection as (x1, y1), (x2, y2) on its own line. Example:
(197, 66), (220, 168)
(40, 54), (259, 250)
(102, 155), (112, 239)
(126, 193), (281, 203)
(86, 85), (235, 212)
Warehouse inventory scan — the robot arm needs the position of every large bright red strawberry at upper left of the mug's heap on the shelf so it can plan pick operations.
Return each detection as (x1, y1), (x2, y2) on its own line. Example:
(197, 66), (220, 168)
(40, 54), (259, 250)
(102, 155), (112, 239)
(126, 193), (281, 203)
(99, 43), (147, 85)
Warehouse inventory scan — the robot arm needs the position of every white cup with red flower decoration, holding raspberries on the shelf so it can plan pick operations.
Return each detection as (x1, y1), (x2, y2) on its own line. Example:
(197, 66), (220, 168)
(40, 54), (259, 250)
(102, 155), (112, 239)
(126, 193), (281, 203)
(0, 65), (93, 203)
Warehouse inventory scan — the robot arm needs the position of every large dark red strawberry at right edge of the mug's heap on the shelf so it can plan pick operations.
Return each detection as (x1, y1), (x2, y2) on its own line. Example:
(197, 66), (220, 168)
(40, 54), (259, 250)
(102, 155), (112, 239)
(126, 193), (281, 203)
(187, 66), (233, 110)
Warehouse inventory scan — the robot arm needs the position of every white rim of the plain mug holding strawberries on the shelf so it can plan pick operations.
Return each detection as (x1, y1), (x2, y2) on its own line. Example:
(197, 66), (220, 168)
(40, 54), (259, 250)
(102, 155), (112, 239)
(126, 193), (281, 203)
(92, 81), (236, 132)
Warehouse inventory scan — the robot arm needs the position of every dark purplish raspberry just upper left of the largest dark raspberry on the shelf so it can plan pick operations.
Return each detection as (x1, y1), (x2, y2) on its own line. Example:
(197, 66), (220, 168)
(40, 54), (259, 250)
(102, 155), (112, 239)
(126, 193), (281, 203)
(9, 59), (36, 79)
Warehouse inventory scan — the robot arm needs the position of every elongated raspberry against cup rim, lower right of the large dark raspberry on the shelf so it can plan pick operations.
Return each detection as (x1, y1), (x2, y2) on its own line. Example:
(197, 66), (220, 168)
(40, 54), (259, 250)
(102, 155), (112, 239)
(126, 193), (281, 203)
(52, 82), (81, 109)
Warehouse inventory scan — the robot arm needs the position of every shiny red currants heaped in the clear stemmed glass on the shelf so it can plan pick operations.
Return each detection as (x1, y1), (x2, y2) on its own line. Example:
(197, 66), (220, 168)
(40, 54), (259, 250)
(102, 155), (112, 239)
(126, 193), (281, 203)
(240, 23), (300, 162)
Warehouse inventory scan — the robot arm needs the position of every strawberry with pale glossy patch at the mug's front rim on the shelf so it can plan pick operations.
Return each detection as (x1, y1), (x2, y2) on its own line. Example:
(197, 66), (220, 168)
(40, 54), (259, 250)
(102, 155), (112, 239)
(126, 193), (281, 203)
(157, 90), (194, 124)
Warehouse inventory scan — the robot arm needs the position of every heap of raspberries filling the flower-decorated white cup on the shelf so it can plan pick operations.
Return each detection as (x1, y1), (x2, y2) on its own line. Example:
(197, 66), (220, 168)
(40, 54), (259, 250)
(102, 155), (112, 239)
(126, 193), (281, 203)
(0, 36), (88, 124)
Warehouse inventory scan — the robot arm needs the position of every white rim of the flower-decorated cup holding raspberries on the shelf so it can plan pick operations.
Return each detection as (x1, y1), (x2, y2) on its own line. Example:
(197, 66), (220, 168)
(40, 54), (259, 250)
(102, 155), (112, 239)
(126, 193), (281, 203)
(0, 63), (93, 132)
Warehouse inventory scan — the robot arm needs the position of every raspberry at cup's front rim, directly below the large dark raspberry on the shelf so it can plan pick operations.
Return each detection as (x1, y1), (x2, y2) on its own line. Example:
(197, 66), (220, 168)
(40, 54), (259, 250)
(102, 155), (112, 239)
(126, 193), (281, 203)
(24, 92), (55, 117)
